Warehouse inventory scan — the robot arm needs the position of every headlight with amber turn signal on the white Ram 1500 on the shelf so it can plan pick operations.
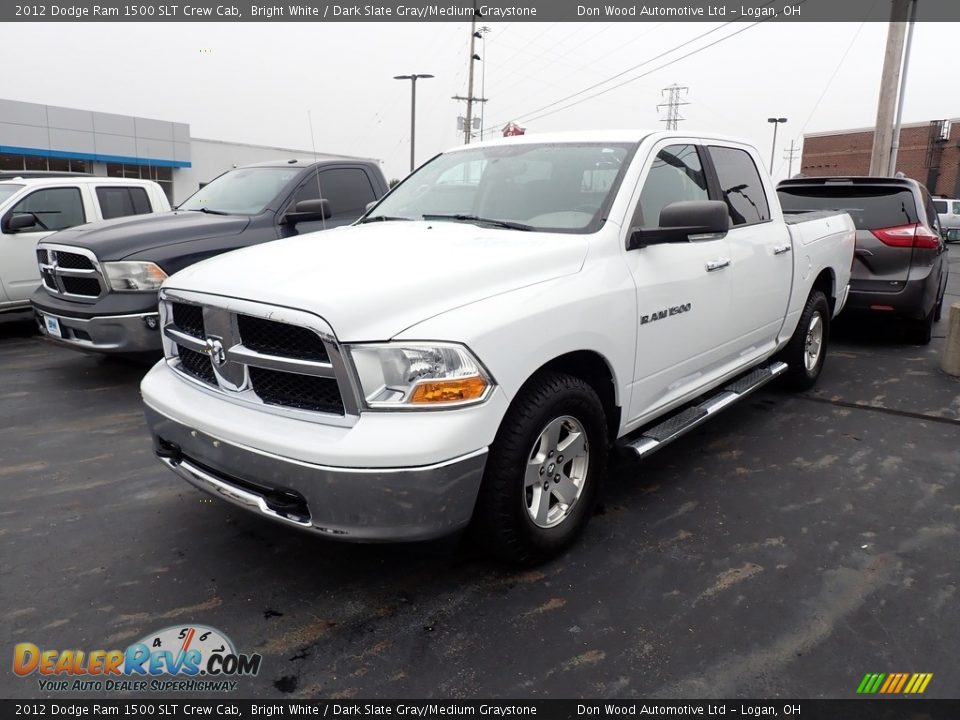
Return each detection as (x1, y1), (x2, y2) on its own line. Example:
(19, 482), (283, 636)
(350, 343), (493, 409)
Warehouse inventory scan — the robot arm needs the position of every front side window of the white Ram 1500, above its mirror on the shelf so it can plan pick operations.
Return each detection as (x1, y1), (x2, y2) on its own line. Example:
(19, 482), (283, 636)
(633, 145), (710, 227)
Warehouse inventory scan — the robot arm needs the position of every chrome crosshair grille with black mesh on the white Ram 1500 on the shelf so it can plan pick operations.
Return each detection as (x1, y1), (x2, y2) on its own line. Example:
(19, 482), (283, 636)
(163, 298), (349, 417)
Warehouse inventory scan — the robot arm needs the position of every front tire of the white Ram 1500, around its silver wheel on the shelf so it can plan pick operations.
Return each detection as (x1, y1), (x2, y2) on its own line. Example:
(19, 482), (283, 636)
(473, 372), (609, 565)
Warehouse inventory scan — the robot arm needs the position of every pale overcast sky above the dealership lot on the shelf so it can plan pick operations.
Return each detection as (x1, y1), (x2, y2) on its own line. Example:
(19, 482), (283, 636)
(7, 22), (960, 179)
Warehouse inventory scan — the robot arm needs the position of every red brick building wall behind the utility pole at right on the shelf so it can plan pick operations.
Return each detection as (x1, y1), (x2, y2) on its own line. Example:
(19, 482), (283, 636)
(800, 121), (960, 197)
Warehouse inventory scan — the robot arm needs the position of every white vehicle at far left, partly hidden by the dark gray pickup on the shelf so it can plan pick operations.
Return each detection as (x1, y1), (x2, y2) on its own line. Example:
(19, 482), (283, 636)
(0, 173), (170, 315)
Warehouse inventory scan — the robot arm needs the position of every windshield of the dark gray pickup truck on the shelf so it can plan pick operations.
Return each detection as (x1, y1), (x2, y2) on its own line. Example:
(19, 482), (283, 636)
(178, 167), (301, 215)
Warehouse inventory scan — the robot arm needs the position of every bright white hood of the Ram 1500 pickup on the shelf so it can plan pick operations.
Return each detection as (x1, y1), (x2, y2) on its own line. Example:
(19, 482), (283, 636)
(164, 221), (588, 342)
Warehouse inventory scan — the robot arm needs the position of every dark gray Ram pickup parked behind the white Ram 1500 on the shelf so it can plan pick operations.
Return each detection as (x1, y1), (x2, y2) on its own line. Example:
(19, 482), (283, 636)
(31, 158), (388, 353)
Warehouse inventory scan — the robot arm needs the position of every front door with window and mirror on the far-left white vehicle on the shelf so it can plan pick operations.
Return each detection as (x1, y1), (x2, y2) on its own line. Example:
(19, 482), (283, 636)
(0, 187), (87, 303)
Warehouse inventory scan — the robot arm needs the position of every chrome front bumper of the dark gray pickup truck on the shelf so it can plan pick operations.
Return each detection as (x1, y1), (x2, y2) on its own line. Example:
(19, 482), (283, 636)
(35, 310), (162, 353)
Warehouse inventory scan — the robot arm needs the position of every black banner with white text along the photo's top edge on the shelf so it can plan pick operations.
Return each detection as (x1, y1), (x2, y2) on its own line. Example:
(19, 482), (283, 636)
(0, 0), (960, 22)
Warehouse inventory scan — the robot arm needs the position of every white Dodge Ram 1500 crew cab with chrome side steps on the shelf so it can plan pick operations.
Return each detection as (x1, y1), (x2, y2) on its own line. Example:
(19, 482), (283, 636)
(142, 131), (855, 563)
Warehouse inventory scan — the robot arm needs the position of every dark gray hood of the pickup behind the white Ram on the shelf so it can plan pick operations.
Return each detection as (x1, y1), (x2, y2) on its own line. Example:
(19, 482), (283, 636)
(49, 210), (250, 260)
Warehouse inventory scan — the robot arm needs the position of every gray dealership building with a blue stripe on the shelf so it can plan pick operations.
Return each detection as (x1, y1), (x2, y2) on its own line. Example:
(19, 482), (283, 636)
(0, 99), (368, 204)
